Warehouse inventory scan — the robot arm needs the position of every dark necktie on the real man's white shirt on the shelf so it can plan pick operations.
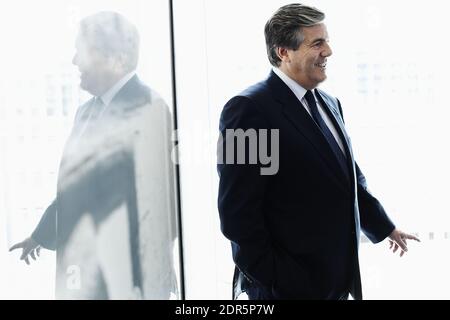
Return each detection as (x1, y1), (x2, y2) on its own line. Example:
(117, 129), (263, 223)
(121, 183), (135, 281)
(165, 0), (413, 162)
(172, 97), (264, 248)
(305, 90), (350, 178)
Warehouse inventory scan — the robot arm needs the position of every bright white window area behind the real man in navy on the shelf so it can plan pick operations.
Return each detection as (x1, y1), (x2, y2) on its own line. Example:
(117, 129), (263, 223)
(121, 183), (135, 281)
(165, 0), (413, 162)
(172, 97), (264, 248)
(175, 0), (450, 299)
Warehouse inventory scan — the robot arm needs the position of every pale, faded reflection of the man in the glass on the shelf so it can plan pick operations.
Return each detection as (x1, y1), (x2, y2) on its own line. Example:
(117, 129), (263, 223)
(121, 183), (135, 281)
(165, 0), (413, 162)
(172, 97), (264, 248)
(11, 12), (176, 299)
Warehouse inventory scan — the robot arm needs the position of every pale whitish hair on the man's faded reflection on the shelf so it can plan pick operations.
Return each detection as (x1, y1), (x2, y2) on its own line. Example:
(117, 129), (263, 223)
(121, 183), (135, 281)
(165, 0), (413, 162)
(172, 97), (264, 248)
(80, 11), (139, 71)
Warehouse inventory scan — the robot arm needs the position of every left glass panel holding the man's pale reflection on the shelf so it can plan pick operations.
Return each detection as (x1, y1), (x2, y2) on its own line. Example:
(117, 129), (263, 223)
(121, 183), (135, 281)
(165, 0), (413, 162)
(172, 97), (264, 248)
(0, 0), (180, 299)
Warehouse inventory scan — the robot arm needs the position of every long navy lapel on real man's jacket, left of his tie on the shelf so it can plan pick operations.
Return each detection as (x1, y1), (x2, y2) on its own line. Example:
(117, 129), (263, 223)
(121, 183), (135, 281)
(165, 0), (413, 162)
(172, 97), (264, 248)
(267, 71), (350, 189)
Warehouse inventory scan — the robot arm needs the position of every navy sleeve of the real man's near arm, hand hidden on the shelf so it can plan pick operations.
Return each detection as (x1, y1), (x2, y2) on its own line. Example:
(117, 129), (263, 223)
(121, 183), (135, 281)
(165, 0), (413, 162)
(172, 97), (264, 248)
(218, 96), (311, 299)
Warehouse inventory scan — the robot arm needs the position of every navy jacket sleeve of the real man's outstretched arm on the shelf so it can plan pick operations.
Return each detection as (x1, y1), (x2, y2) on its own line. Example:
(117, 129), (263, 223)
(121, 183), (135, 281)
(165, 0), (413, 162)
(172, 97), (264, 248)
(338, 100), (395, 243)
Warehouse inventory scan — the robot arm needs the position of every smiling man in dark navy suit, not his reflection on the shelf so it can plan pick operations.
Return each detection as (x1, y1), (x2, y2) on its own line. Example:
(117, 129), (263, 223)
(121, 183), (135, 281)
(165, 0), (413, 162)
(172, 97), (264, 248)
(218, 4), (418, 299)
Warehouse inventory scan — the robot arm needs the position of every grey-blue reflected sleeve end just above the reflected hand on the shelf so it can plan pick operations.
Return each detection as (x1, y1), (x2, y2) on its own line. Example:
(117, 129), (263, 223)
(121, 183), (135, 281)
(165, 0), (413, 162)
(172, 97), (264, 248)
(31, 200), (57, 250)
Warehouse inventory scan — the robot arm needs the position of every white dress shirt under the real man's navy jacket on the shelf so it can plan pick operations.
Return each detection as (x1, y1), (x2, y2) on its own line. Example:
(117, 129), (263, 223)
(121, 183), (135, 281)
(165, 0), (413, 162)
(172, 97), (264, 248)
(273, 68), (346, 155)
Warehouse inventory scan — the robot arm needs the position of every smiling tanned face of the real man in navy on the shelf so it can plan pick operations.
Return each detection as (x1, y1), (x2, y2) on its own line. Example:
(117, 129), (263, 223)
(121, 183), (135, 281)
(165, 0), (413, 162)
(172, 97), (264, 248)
(280, 23), (333, 90)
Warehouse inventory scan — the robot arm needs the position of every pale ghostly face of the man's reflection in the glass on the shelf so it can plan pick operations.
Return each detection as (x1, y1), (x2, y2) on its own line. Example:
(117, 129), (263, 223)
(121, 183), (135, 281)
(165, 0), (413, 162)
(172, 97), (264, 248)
(72, 35), (117, 96)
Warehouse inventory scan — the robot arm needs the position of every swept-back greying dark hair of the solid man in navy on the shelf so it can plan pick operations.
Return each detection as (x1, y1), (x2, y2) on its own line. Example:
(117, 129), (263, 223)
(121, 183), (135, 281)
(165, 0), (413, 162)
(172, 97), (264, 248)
(264, 3), (325, 67)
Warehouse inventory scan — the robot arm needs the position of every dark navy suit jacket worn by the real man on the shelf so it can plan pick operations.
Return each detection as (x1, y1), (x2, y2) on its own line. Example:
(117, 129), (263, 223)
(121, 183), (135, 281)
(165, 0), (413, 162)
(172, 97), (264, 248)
(218, 72), (394, 299)
